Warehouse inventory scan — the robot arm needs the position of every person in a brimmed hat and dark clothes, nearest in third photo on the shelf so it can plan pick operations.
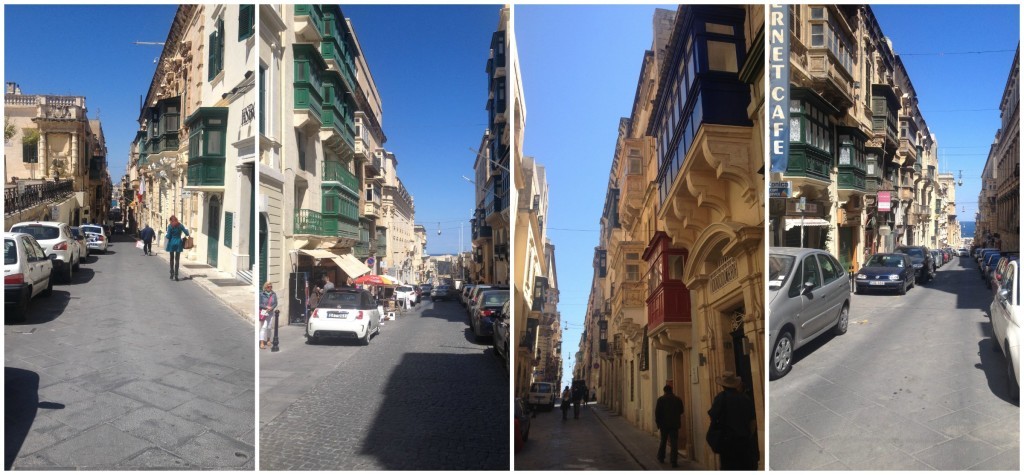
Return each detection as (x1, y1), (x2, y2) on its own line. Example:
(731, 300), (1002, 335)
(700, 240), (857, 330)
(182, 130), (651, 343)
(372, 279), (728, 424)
(708, 373), (761, 470)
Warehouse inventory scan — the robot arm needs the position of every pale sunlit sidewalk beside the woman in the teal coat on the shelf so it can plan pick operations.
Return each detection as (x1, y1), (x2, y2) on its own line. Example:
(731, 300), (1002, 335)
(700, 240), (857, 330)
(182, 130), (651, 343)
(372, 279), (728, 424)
(135, 235), (256, 323)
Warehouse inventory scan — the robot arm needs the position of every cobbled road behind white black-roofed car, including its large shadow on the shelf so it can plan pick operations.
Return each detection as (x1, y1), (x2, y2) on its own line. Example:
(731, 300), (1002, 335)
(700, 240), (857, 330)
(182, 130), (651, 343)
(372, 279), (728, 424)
(259, 301), (511, 470)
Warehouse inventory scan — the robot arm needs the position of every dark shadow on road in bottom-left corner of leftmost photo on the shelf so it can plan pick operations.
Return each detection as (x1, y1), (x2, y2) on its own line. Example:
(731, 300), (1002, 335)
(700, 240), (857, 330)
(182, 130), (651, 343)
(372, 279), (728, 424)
(3, 366), (65, 470)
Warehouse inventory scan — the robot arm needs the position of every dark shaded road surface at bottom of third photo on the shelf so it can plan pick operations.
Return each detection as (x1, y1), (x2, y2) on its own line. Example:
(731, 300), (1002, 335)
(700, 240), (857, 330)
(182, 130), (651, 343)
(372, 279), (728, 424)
(514, 402), (701, 471)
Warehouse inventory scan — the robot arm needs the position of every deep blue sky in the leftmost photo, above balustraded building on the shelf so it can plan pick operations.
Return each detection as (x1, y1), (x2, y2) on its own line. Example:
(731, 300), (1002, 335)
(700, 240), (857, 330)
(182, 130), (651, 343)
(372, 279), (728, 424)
(4, 5), (177, 183)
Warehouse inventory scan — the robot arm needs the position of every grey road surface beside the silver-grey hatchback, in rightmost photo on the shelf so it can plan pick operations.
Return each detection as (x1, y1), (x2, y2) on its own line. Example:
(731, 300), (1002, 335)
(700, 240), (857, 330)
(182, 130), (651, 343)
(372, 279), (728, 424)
(768, 253), (1020, 470)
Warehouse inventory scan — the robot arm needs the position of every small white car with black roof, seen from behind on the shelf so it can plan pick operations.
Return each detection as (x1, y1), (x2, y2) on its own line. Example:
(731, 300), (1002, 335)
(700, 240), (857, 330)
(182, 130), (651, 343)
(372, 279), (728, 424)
(306, 288), (381, 345)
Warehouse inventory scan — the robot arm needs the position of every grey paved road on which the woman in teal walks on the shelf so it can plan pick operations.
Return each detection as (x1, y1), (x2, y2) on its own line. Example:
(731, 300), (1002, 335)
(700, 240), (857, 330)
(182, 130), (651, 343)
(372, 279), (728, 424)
(4, 234), (255, 470)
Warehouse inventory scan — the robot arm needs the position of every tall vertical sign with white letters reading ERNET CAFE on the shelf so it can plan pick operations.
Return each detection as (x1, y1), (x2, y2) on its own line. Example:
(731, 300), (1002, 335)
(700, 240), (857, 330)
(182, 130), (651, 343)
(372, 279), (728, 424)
(768, 5), (790, 173)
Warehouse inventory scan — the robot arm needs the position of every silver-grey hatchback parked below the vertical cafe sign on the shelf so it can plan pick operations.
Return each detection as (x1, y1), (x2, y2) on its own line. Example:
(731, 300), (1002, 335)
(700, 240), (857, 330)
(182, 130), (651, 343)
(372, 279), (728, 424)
(768, 248), (850, 379)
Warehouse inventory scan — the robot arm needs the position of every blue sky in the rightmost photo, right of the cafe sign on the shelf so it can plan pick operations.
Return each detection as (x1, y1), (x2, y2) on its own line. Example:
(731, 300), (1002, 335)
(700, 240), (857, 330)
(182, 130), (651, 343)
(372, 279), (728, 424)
(871, 5), (1020, 228)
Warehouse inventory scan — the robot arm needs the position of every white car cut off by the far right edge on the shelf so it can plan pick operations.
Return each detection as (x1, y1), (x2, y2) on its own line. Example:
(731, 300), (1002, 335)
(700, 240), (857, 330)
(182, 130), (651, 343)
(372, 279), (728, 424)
(988, 261), (1021, 400)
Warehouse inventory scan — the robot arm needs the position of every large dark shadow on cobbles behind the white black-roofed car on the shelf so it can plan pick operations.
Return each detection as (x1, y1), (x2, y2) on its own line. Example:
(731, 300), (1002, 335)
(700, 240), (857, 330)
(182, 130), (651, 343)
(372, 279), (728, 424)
(359, 353), (511, 471)
